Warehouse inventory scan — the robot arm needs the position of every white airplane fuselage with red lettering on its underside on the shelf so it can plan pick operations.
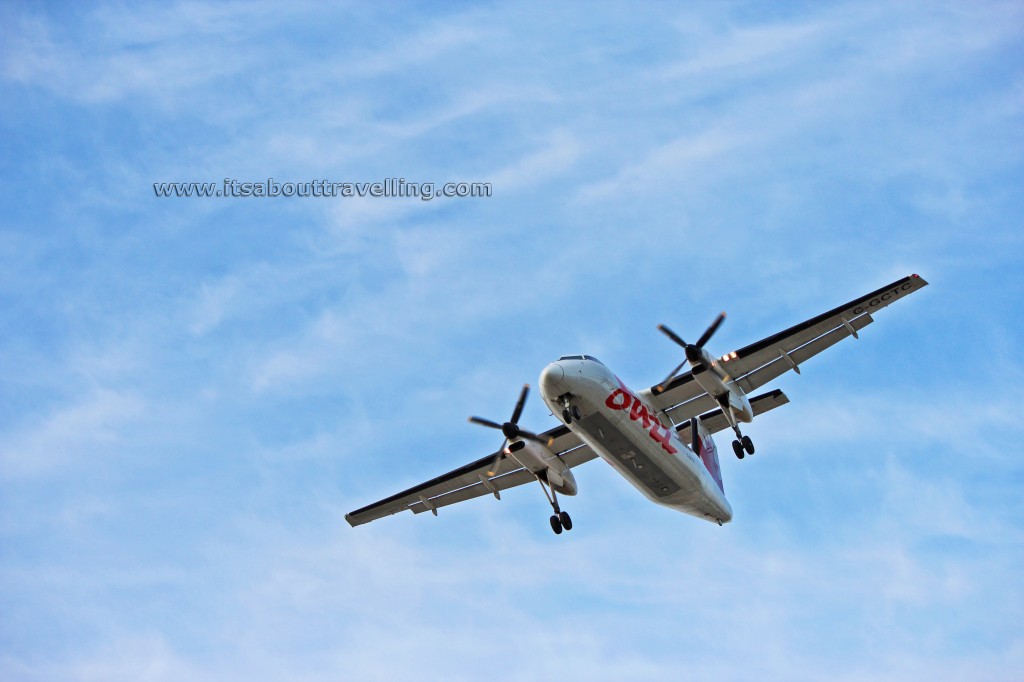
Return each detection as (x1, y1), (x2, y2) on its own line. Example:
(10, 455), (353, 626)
(541, 356), (732, 523)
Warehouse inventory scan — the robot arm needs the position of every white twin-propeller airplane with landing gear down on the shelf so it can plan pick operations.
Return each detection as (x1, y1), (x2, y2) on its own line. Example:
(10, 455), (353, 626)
(345, 274), (928, 534)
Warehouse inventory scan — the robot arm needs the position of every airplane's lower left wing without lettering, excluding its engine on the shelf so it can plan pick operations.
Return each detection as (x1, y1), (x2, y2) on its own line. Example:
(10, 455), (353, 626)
(345, 426), (597, 526)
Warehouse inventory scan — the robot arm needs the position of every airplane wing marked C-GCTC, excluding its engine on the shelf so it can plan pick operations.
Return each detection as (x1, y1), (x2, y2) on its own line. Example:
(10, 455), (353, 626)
(650, 274), (928, 424)
